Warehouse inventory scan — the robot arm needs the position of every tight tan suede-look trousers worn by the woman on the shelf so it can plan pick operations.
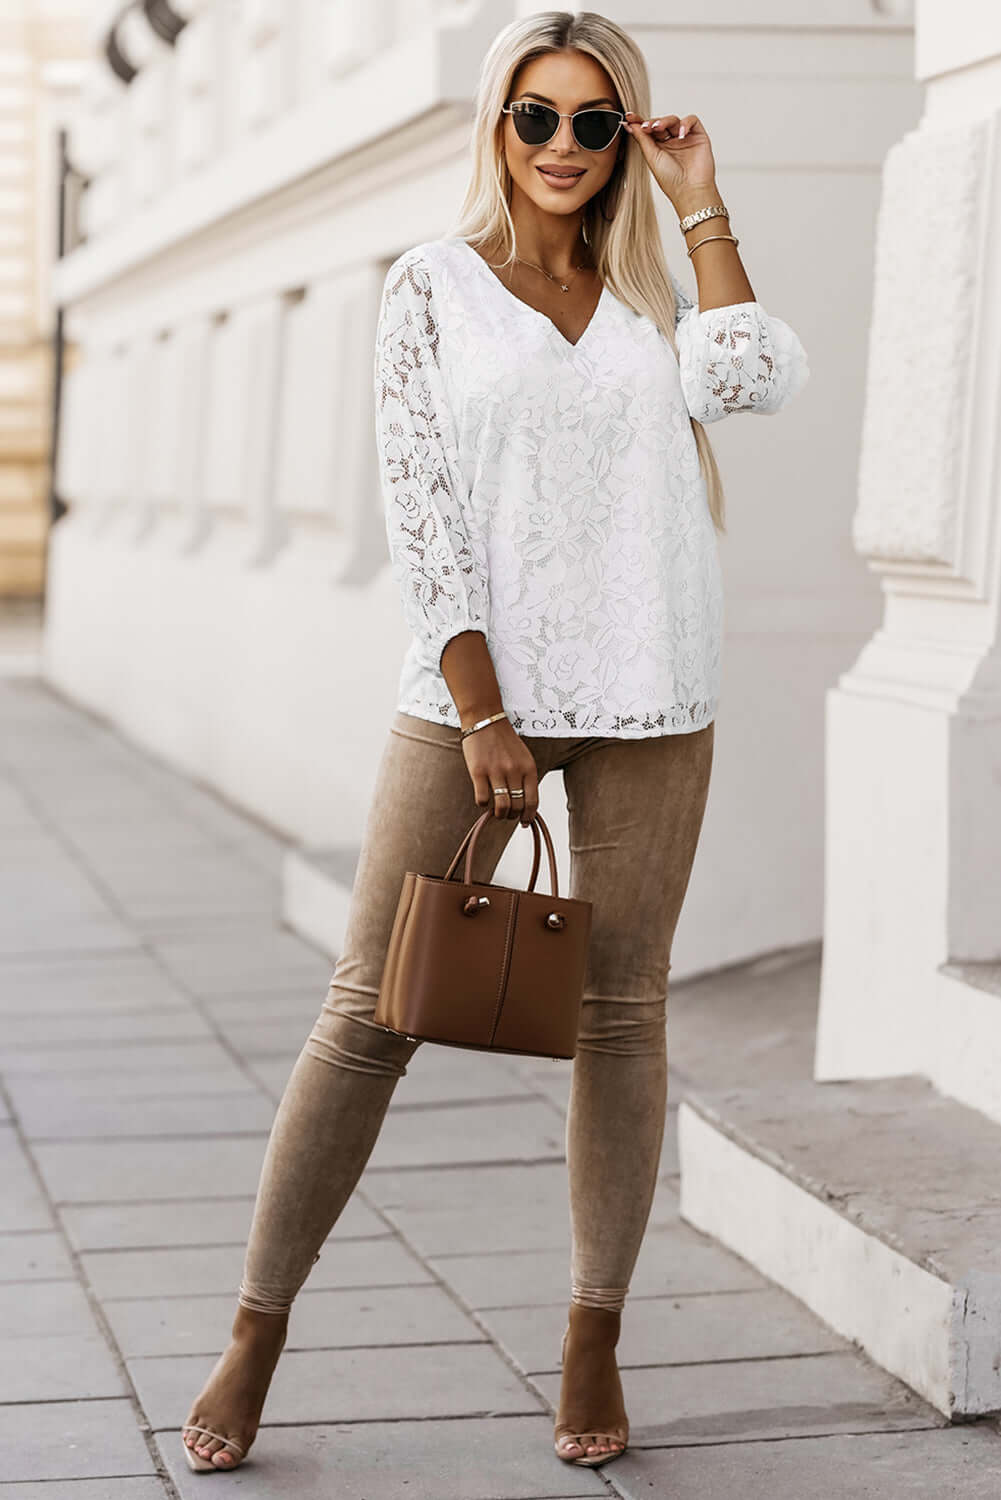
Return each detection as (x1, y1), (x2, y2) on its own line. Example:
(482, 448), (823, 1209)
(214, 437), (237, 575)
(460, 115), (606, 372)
(240, 710), (714, 1313)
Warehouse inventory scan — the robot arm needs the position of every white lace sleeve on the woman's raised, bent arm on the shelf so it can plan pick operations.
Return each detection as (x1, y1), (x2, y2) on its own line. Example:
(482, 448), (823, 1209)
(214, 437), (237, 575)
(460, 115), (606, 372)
(671, 273), (810, 422)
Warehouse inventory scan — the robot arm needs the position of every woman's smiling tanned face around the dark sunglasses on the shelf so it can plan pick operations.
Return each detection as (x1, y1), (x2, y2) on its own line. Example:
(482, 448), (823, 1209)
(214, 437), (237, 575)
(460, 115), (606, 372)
(504, 48), (626, 215)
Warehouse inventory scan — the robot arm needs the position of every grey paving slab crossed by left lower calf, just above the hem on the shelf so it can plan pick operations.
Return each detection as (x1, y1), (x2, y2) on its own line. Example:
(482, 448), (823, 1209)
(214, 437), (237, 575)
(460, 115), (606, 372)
(81, 1236), (434, 1298)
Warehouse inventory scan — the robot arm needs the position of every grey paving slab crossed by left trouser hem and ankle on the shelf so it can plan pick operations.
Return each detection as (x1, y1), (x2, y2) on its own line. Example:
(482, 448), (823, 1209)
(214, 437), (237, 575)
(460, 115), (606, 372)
(104, 1286), (486, 1358)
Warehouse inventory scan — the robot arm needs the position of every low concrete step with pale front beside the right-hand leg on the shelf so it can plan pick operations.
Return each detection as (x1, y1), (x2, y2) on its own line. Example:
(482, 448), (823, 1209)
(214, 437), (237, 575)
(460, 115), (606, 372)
(678, 1077), (1001, 1419)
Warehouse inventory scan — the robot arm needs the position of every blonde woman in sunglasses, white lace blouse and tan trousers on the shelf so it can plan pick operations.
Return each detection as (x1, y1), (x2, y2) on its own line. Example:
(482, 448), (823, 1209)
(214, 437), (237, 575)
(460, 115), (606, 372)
(177, 2), (807, 1469)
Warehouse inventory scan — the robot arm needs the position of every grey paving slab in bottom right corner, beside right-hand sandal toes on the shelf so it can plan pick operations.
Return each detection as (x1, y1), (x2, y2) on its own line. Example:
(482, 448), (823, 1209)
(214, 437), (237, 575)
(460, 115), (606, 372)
(603, 1425), (1001, 1500)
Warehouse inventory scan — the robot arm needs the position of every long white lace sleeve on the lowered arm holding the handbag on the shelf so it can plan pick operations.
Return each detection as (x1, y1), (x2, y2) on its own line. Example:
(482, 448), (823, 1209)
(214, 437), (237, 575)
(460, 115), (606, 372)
(375, 251), (489, 672)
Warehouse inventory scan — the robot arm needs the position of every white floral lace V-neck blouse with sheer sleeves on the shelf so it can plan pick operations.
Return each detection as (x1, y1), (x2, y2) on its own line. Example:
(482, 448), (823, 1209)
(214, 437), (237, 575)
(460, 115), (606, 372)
(375, 237), (809, 738)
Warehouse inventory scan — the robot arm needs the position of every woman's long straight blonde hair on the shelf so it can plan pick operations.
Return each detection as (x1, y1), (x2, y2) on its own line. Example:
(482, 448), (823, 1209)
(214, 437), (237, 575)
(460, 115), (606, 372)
(447, 11), (726, 533)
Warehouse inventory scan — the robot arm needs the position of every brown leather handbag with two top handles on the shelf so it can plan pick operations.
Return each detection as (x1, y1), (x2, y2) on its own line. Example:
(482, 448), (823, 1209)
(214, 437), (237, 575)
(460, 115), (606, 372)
(375, 812), (591, 1058)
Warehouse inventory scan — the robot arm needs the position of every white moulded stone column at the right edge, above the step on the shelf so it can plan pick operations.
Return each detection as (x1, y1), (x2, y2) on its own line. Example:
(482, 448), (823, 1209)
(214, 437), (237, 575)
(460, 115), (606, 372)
(815, 11), (1001, 1092)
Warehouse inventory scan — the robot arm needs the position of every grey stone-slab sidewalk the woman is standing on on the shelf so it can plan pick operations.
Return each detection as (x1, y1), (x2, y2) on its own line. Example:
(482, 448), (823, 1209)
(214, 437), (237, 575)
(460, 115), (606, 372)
(0, 677), (1001, 1500)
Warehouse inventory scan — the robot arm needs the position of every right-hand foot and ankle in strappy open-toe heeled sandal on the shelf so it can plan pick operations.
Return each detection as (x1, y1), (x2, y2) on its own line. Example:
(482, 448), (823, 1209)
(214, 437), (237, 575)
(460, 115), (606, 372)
(552, 1302), (629, 1469)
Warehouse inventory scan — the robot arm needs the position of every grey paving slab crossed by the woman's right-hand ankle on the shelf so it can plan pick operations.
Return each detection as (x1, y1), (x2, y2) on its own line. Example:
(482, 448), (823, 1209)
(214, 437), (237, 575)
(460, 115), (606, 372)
(479, 1287), (851, 1374)
